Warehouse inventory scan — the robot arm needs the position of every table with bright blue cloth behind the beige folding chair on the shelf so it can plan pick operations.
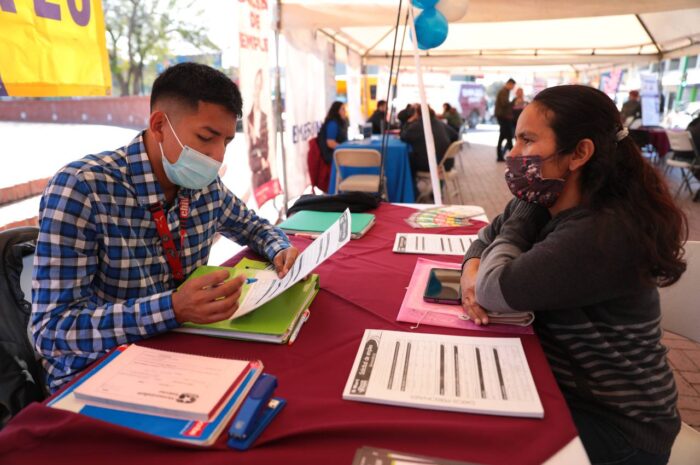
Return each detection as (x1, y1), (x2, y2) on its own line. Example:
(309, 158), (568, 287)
(328, 136), (416, 203)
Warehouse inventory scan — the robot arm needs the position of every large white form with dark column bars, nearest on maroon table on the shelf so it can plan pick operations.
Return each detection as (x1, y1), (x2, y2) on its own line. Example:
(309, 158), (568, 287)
(343, 329), (544, 418)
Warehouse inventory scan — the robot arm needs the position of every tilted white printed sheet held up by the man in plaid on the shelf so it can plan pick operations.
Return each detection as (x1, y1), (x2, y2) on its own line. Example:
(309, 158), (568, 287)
(231, 209), (352, 320)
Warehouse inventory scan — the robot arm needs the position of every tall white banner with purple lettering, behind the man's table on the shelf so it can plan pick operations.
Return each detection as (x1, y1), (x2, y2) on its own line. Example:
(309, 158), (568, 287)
(284, 29), (330, 198)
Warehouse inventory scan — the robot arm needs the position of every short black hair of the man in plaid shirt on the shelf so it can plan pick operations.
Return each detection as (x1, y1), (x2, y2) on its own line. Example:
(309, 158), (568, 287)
(151, 63), (243, 118)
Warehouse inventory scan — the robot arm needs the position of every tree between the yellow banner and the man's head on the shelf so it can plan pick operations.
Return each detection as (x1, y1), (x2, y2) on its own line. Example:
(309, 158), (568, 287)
(103, 0), (216, 95)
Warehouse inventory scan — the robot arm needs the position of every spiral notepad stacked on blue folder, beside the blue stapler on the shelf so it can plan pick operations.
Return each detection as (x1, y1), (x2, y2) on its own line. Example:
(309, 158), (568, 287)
(48, 345), (263, 445)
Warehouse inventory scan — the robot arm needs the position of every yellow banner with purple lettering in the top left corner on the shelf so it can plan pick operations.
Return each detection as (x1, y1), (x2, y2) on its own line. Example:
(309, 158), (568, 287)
(0, 0), (112, 97)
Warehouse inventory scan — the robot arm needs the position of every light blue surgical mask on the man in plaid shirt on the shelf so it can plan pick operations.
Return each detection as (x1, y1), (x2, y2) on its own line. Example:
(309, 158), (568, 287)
(158, 115), (221, 189)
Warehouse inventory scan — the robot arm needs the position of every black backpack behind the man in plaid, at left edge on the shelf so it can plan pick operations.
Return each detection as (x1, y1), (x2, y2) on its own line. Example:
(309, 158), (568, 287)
(0, 227), (47, 429)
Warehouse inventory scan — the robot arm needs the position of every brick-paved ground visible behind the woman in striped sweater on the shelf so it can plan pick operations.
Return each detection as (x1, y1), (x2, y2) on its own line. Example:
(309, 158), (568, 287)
(456, 126), (700, 430)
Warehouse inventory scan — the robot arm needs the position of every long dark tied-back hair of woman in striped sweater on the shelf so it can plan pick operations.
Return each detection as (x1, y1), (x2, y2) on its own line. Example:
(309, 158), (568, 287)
(534, 85), (688, 286)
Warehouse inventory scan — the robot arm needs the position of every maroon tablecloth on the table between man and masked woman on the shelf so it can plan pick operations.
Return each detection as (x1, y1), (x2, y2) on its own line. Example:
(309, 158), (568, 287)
(0, 205), (576, 465)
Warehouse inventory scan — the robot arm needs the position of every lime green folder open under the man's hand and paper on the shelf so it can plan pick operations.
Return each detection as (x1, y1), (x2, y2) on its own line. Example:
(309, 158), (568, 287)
(175, 258), (319, 344)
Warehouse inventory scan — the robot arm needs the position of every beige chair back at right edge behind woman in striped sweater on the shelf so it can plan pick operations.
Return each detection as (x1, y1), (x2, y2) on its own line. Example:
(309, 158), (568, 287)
(659, 241), (700, 342)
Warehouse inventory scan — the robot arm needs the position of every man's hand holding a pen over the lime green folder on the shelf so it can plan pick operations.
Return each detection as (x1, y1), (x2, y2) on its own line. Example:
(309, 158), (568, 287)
(172, 270), (245, 324)
